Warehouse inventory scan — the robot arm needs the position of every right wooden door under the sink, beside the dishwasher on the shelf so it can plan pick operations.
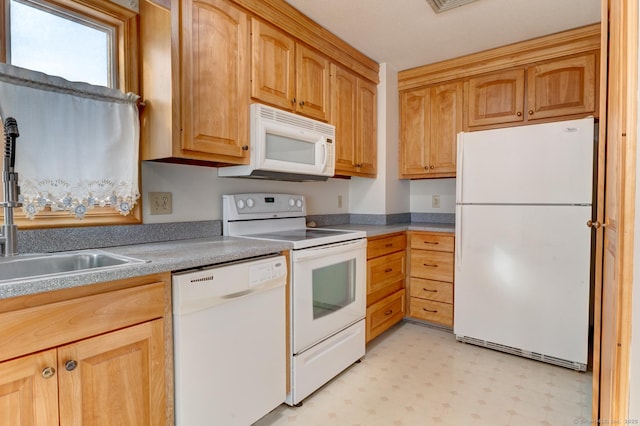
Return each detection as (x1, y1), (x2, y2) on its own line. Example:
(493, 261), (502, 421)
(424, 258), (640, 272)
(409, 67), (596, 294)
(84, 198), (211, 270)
(58, 319), (166, 426)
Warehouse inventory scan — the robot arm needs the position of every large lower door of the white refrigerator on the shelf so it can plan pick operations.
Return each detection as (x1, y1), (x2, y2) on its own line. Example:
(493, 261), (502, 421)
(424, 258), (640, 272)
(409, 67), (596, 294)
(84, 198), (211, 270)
(454, 206), (591, 364)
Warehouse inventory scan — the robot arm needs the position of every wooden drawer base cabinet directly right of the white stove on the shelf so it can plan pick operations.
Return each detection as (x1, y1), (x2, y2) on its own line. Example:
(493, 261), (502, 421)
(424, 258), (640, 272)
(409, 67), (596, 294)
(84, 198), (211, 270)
(366, 232), (406, 343)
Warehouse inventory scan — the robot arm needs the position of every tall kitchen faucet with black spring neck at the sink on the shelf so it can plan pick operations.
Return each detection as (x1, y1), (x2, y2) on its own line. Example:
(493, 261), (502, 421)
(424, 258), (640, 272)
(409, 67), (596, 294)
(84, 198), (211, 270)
(0, 117), (22, 256)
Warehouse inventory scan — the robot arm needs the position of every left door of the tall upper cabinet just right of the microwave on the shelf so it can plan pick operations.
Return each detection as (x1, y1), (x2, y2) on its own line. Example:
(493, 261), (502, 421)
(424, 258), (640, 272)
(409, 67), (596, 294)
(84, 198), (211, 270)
(331, 64), (358, 176)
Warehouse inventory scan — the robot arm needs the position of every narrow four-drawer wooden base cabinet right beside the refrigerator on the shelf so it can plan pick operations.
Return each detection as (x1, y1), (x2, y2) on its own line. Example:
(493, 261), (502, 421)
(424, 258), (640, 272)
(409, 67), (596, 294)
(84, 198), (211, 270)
(409, 231), (454, 327)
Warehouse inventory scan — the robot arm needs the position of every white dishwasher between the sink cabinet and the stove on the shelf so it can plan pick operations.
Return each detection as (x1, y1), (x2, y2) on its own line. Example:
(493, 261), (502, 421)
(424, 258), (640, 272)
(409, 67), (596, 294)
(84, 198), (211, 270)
(172, 256), (287, 426)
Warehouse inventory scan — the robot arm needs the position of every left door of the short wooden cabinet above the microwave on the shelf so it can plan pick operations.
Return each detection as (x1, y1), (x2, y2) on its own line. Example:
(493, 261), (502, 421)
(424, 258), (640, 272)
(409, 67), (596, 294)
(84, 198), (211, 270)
(251, 18), (296, 110)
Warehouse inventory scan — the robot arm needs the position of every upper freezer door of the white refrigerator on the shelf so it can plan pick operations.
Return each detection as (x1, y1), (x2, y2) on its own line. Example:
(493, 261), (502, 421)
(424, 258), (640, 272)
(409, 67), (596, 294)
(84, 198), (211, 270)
(456, 118), (594, 204)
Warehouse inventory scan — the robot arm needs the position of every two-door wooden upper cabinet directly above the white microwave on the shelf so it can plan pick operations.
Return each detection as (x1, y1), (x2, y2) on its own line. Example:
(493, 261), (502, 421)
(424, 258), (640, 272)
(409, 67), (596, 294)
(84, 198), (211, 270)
(251, 18), (330, 121)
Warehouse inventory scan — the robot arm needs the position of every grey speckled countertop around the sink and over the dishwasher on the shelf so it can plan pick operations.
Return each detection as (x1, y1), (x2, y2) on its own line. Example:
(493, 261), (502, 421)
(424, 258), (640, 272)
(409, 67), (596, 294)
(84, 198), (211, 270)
(0, 236), (291, 299)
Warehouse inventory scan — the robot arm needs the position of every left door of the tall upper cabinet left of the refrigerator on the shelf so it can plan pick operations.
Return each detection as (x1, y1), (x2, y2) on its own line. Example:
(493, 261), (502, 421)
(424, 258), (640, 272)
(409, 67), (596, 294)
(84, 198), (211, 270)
(400, 88), (431, 178)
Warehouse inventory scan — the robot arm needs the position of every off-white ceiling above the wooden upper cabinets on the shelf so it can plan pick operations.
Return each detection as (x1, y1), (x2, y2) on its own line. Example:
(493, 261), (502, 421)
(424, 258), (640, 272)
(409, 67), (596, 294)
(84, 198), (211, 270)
(285, 0), (601, 71)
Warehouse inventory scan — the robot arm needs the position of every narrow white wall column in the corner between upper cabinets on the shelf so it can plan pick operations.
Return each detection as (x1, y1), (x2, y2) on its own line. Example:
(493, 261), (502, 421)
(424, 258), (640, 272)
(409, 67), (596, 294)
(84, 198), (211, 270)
(349, 64), (409, 214)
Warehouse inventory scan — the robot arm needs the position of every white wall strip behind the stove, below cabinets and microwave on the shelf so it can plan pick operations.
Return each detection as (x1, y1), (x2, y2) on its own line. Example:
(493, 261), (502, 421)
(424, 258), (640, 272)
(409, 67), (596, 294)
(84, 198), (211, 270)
(142, 161), (349, 223)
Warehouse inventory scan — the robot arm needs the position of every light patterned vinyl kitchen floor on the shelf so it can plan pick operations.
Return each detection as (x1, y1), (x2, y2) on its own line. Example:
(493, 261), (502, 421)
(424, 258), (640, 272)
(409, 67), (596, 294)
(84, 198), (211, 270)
(254, 322), (591, 426)
